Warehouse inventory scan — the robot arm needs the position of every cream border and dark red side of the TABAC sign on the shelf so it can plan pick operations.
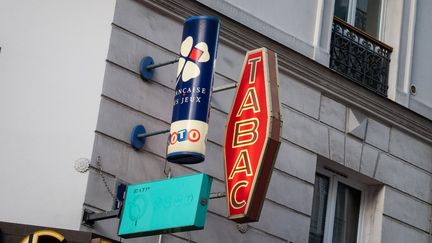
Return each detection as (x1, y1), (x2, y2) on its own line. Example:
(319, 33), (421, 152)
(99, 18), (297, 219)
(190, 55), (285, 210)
(224, 48), (282, 223)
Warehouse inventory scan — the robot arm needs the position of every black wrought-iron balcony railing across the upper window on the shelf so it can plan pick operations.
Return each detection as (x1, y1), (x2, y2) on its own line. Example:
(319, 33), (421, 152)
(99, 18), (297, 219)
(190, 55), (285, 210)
(330, 17), (393, 97)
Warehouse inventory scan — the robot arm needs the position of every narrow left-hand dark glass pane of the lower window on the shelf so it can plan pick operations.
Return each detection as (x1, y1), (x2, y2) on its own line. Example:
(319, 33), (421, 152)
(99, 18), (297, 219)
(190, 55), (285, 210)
(309, 174), (330, 243)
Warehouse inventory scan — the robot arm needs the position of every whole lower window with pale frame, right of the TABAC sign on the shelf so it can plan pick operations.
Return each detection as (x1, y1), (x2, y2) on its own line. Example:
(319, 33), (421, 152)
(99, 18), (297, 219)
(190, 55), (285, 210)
(309, 174), (363, 243)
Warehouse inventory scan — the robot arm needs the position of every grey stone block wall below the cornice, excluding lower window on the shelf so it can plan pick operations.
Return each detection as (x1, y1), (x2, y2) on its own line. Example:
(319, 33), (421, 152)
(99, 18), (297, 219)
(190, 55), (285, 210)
(83, 1), (432, 243)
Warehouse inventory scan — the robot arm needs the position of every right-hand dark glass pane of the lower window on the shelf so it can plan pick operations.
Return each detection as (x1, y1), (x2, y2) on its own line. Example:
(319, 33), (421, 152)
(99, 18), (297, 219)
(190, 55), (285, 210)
(333, 183), (361, 243)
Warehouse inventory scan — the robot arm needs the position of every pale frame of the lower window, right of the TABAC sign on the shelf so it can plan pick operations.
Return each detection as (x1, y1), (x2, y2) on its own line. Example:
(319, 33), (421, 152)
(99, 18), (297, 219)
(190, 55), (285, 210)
(316, 168), (367, 243)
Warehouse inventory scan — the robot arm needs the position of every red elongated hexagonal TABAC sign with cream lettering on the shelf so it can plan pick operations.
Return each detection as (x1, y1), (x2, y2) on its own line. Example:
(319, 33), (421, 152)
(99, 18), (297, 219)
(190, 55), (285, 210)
(224, 48), (282, 223)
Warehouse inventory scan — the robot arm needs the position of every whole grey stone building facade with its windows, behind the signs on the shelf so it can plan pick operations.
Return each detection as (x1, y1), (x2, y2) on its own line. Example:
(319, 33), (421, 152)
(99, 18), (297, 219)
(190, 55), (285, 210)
(0, 0), (432, 243)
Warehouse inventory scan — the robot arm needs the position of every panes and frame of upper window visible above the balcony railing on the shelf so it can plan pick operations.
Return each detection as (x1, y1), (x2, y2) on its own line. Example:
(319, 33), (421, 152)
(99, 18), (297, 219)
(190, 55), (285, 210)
(334, 0), (381, 39)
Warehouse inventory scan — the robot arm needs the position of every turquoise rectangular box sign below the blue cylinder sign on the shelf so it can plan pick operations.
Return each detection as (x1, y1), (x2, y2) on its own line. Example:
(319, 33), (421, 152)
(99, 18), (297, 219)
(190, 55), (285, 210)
(118, 174), (212, 238)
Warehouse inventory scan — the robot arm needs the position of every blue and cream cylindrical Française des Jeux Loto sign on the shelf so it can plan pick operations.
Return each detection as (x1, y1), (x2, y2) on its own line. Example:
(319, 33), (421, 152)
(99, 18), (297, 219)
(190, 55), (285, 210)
(167, 16), (220, 164)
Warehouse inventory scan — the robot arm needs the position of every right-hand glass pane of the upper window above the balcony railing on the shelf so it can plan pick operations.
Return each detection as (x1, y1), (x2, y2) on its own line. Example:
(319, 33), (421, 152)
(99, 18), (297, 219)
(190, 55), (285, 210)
(354, 0), (381, 38)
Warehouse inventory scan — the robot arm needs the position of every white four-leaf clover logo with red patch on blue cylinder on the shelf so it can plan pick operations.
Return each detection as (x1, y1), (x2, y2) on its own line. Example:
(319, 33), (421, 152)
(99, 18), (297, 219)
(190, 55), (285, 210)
(177, 36), (210, 82)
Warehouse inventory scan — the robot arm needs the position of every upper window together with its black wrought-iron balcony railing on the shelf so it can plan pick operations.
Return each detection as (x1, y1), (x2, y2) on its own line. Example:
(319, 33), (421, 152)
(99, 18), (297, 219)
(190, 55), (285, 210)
(329, 0), (393, 97)
